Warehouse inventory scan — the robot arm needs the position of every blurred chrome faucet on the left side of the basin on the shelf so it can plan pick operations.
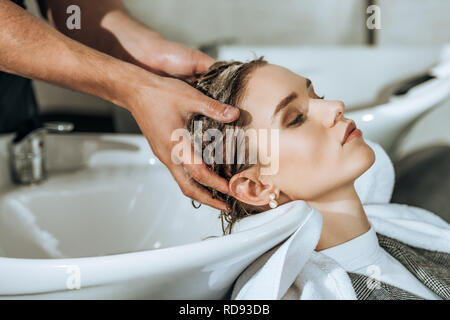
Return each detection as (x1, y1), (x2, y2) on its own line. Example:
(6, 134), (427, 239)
(9, 122), (73, 185)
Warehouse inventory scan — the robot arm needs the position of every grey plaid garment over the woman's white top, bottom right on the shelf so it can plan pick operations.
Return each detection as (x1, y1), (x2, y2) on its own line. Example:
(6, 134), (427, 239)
(348, 233), (450, 300)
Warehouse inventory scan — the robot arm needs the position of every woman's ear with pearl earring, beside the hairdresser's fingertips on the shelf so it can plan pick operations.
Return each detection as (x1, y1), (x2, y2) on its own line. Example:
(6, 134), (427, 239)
(228, 166), (279, 206)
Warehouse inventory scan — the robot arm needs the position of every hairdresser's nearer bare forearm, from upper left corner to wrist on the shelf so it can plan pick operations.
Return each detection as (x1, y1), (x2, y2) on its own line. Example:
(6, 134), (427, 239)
(0, 0), (154, 107)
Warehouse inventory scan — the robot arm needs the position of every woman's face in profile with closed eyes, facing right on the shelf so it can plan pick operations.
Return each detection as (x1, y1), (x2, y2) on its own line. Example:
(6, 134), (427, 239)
(240, 64), (375, 201)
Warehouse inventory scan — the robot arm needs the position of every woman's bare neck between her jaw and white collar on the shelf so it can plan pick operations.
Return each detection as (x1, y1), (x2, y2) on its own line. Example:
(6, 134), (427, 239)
(308, 183), (370, 251)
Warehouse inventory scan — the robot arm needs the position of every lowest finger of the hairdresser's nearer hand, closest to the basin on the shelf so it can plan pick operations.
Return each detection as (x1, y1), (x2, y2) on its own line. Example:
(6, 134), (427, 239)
(169, 165), (227, 210)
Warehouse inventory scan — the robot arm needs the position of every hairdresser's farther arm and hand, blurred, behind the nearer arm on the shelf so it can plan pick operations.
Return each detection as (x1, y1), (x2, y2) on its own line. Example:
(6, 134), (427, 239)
(41, 0), (214, 80)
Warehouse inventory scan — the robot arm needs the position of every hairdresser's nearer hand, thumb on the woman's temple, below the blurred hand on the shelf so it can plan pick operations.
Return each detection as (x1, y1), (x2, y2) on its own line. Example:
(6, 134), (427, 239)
(125, 71), (239, 210)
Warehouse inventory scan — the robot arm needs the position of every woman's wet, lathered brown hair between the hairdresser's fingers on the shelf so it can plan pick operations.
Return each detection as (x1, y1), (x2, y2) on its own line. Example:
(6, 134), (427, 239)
(187, 57), (267, 234)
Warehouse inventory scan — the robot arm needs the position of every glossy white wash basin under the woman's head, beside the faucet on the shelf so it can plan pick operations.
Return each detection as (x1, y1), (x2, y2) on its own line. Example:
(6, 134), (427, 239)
(0, 134), (305, 299)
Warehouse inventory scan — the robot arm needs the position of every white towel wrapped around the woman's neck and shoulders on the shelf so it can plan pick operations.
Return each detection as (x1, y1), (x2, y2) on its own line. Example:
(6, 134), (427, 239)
(231, 140), (450, 300)
